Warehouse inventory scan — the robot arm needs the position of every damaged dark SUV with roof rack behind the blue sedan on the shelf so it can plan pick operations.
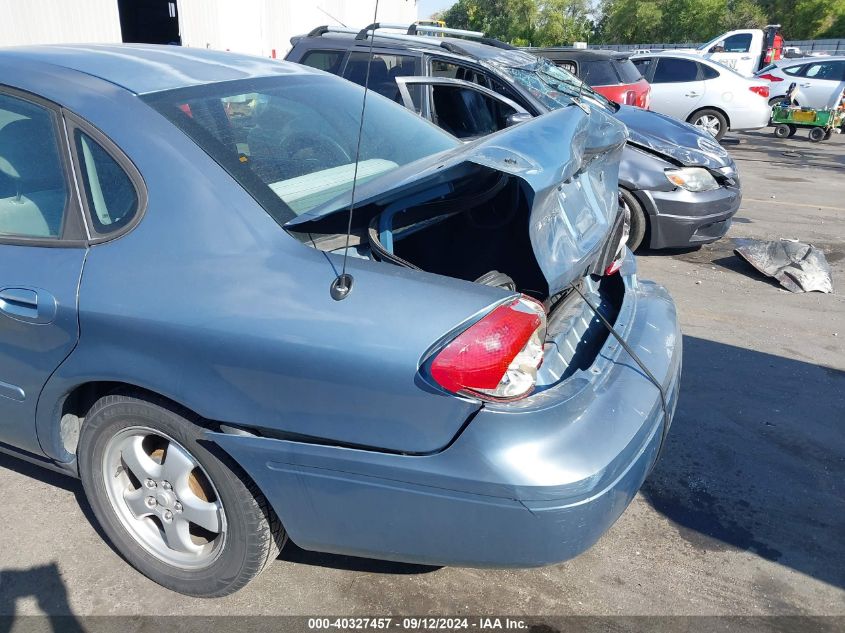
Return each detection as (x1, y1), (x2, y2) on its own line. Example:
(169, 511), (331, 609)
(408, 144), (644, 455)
(286, 25), (741, 249)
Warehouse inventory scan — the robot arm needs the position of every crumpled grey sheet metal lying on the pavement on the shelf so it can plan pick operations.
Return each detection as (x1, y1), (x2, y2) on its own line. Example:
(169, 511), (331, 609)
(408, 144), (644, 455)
(734, 239), (833, 292)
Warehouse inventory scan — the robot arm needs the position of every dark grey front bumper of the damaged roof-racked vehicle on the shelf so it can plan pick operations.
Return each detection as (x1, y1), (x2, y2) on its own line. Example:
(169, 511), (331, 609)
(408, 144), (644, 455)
(634, 181), (742, 249)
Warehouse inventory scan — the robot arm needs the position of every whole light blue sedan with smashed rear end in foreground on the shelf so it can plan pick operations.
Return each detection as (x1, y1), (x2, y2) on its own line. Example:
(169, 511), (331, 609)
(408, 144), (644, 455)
(0, 45), (681, 596)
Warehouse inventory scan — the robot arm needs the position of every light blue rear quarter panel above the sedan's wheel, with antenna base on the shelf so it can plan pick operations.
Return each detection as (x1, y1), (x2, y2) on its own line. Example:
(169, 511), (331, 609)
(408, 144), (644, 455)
(29, 66), (507, 459)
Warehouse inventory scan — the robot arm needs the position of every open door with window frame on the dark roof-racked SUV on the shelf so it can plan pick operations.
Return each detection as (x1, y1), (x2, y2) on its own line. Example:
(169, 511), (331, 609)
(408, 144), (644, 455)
(396, 77), (531, 141)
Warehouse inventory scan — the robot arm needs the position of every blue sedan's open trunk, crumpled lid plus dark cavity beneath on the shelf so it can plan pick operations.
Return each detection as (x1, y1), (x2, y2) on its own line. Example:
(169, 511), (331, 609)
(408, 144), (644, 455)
(286, 105), (626, 301)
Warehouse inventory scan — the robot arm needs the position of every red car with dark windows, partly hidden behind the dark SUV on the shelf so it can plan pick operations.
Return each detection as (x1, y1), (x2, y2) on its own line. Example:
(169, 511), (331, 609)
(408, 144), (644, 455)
(528, 48), (651, 110)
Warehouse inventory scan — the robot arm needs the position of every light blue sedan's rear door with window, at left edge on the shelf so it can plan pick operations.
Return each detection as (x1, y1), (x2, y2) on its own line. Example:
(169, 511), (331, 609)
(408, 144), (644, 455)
(0, 89), (87, 453)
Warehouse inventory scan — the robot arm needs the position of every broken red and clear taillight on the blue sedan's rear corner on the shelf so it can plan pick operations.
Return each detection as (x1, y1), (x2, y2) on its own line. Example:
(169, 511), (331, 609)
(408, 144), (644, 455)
(430, 296), (546, 400)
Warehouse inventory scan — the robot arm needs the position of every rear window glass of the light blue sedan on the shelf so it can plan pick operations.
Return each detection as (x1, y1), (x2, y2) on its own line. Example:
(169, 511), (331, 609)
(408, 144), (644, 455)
(144, 75), (460, 224)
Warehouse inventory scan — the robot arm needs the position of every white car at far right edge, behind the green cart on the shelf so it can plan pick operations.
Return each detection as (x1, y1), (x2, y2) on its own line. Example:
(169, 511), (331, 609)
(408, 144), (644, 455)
(752, 57), (845, 108)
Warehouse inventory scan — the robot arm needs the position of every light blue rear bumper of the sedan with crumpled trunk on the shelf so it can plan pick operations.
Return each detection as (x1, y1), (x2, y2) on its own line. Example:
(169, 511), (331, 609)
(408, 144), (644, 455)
(210, 259), (681, 567)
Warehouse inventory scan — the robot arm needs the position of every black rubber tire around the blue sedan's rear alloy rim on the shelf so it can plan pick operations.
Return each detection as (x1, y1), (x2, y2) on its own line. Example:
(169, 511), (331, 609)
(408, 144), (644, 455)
(78, 392), (287, 598)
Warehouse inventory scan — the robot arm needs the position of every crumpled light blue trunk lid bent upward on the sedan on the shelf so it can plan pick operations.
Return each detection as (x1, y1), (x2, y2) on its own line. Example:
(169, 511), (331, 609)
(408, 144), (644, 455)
(285, 104), (627, 295)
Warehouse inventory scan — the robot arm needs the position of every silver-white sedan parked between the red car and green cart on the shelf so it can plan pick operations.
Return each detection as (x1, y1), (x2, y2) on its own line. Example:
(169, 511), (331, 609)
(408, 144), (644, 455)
(631, 51), (771, 139)
